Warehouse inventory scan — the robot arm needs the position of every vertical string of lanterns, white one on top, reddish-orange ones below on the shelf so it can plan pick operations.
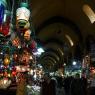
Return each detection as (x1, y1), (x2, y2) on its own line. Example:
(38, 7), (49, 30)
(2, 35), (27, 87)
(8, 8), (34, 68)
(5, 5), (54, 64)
(12, 2), (36, 72)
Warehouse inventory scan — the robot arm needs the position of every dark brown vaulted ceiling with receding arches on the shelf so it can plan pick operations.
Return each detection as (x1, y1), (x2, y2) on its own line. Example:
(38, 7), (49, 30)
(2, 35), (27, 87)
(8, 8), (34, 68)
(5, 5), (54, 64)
(7, 0), (95, 71)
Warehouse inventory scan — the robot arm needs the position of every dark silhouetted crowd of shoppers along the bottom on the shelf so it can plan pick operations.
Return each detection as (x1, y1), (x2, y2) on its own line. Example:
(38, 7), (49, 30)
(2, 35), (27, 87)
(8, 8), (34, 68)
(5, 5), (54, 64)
(17, 73), (95, 95)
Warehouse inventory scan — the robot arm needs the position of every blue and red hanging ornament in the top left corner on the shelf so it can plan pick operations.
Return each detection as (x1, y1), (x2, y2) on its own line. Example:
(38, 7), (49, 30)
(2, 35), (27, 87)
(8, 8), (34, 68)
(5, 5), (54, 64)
(0, 0), (10, 36)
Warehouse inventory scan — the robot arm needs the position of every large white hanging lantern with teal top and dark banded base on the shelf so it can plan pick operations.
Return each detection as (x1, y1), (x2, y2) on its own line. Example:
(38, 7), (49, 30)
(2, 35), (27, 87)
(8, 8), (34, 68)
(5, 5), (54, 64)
(16, 2), (30, 30)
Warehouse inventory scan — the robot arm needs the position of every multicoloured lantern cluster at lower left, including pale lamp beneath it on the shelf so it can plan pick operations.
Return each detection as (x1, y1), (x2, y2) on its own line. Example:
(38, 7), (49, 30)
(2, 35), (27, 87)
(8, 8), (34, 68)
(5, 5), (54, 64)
(0, 44), (17, 88)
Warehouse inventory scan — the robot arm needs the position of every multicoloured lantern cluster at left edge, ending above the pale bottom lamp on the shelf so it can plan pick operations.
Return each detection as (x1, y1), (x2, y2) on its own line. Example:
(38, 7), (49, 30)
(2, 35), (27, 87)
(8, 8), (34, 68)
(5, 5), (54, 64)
(0, 45), (16, 78)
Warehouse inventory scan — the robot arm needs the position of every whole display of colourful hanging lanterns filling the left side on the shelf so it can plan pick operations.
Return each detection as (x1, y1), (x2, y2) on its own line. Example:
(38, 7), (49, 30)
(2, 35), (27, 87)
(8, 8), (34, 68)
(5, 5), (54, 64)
(0, 0), (37, 88)
